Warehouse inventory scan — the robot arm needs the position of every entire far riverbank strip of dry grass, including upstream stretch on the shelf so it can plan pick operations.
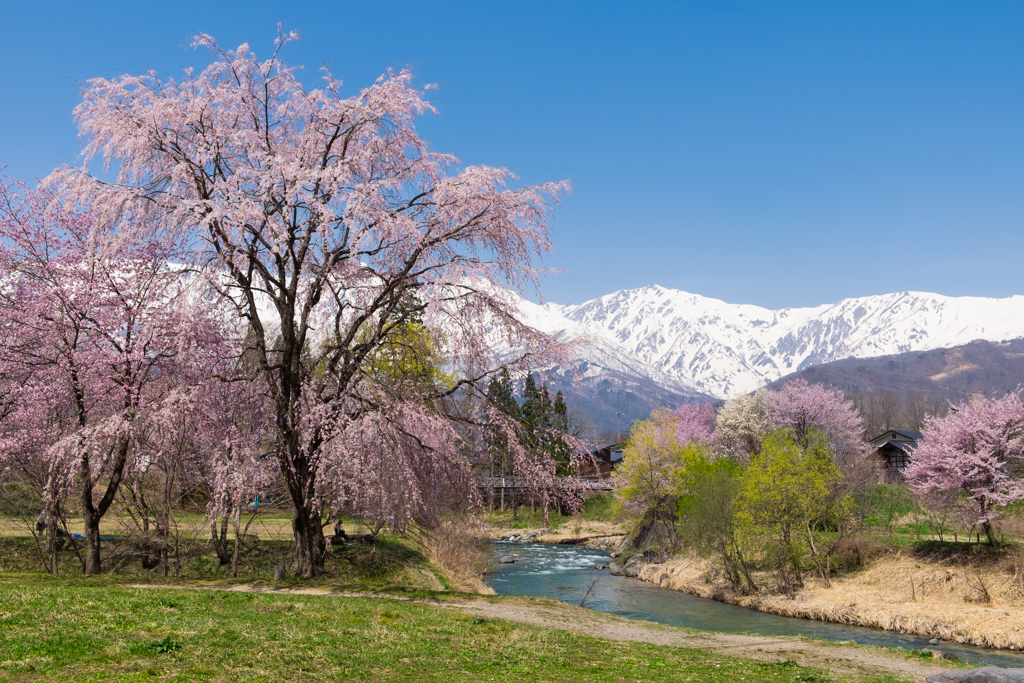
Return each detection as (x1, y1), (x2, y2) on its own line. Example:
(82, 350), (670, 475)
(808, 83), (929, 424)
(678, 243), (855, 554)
(486, 503), (1024, 651)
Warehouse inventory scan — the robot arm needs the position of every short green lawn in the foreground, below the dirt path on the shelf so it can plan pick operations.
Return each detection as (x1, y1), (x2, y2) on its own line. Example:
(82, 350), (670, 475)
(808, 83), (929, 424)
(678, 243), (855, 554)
(0, 581), (909, 683)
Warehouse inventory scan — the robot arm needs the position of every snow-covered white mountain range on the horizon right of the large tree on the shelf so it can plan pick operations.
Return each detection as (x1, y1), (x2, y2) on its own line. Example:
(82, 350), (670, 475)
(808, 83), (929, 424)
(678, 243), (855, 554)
(521, 285), (1024, 398)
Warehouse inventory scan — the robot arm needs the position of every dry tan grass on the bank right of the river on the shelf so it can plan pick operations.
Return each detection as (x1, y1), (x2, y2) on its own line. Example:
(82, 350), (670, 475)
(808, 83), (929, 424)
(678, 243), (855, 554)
(640, 553), (1024, 649)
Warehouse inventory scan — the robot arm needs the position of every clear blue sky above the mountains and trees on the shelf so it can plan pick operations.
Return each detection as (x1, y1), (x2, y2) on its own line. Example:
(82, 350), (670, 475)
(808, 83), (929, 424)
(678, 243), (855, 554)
(0, 0), (1024, 307)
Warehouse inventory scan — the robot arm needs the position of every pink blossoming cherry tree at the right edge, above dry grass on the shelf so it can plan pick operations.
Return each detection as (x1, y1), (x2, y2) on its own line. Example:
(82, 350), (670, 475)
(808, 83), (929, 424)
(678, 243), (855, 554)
(906, 391), (1024, 546)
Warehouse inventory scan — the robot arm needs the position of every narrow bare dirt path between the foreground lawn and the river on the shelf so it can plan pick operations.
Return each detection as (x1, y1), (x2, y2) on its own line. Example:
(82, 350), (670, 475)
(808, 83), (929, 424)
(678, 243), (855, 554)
(126, 585), (950, 681)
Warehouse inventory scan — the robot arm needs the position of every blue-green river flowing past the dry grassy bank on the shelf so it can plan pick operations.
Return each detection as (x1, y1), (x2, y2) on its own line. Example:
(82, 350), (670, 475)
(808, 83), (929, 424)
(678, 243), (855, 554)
(487, 542), (1024, 667)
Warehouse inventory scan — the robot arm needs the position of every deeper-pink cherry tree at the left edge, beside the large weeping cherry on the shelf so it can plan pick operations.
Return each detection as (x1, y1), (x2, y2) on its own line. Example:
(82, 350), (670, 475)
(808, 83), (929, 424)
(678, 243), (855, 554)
(0, 183), (224, 573)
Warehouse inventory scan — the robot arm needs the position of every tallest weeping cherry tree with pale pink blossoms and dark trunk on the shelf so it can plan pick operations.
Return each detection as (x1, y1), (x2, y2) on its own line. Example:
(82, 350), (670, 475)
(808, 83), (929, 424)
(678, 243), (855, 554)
(62, 33), (568, 575)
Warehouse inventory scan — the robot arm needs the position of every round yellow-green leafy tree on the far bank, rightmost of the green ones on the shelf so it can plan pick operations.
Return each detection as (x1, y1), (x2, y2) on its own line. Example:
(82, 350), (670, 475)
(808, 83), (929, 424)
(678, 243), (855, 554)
(736, 429), (842, 597)
